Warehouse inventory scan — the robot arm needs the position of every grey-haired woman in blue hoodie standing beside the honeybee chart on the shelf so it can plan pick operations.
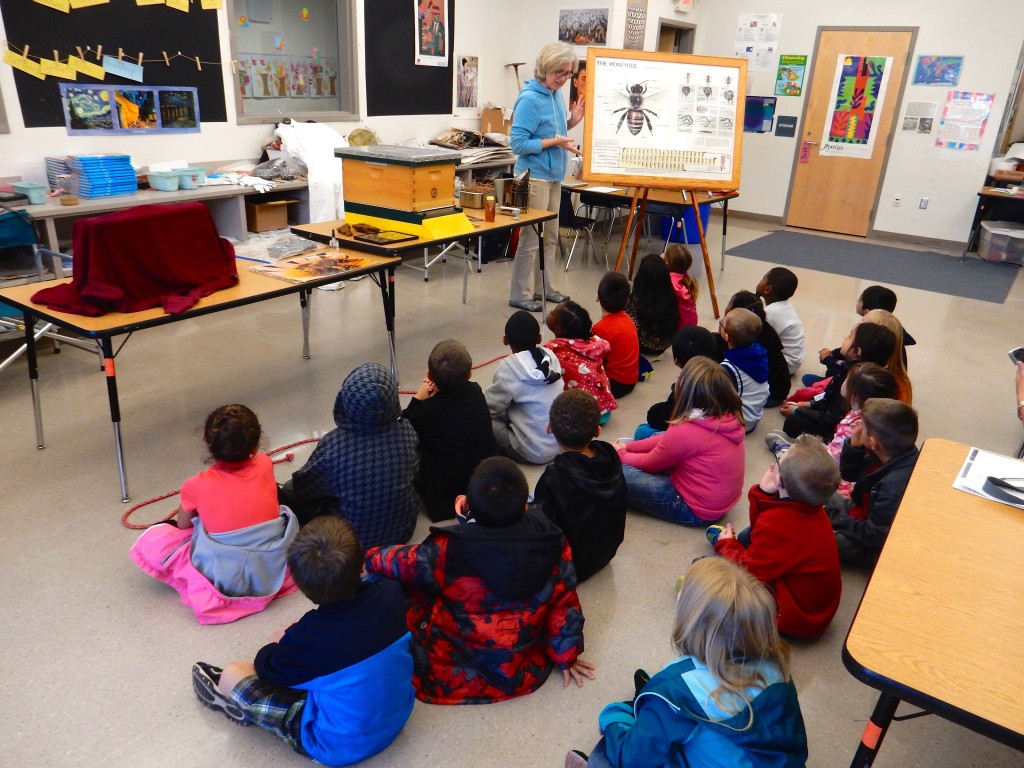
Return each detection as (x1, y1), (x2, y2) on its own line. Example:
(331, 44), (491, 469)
(509, 43), (585, 312)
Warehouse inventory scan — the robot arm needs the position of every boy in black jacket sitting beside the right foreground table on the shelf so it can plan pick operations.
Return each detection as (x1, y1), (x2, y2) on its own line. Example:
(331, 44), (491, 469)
(825, 397), (918, 568)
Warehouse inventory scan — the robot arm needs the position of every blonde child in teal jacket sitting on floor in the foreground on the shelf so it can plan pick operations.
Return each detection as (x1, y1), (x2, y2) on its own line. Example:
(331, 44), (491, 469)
(565, 557), (807, 768)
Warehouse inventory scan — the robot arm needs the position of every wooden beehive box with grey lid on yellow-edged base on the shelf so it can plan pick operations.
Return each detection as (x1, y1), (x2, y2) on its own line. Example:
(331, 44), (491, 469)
(335, 146), (459, 211)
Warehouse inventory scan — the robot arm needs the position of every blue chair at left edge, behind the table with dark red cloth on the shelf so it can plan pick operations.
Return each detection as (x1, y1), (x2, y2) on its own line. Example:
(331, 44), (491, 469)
(0, 206), (102, 371)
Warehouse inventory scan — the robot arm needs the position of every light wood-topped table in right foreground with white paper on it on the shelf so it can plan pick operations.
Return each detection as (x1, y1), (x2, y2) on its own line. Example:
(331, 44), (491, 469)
(843, 438), (1024, 766)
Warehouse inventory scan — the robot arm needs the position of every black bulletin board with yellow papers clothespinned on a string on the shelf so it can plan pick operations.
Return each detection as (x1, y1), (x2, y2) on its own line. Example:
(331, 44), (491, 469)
(0, 0), (227, 128)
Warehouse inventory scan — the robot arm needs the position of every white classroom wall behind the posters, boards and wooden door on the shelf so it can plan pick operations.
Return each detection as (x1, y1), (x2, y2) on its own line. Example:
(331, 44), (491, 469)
(0, 0), (1024, 241)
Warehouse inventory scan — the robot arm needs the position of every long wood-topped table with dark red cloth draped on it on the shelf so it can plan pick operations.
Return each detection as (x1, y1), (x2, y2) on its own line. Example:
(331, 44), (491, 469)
(0, 256), (401, 502)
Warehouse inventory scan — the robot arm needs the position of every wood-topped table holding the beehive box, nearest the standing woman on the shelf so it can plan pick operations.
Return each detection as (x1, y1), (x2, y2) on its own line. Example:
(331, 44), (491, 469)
(292, 208), (558, 304)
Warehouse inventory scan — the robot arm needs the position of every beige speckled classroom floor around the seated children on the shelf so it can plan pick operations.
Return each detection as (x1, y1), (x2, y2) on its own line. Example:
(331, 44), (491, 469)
(0, 213), (1024, 768)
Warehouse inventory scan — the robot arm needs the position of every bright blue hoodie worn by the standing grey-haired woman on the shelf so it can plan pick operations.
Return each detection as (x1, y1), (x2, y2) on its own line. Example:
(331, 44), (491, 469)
(511, 79), (568, 181)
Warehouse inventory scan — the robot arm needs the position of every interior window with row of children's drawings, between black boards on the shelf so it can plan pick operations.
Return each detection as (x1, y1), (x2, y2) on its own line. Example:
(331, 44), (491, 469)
(228, 0), (359, 125)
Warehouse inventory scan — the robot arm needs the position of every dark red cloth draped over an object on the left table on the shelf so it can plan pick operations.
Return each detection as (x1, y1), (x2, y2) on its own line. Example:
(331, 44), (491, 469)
(32, 203), (239, 317)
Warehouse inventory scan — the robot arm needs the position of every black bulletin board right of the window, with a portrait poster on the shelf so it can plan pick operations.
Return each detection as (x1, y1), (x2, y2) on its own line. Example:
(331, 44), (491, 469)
(362, 0), (455, 117)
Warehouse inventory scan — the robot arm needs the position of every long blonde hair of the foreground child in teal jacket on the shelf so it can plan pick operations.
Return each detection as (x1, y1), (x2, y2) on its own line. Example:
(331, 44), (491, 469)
(672, 557), (790, 714)
